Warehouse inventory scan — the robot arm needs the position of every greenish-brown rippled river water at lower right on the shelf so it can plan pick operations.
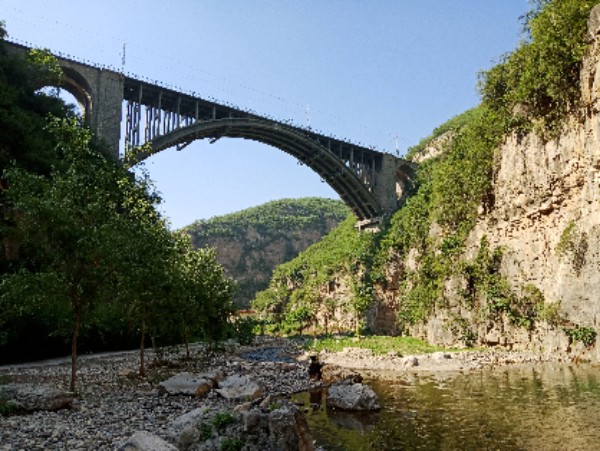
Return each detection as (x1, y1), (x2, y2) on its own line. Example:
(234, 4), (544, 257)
(296, 364), (600, 451)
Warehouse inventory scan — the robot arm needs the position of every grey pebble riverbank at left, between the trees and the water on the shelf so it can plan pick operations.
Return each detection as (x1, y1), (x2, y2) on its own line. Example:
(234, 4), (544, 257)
(0, 340), (320, 451)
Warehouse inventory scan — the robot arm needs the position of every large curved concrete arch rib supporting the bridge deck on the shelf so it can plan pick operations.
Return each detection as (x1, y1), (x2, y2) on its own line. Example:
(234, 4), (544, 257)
(135, 117), (383, 220)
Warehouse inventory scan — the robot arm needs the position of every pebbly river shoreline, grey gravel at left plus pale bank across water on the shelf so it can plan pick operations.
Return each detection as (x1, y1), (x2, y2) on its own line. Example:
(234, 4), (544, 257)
(0, 337), (592, 451)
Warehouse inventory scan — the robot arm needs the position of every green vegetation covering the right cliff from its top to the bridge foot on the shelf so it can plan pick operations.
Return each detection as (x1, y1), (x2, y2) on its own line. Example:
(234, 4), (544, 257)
(254, 0), (596, 343)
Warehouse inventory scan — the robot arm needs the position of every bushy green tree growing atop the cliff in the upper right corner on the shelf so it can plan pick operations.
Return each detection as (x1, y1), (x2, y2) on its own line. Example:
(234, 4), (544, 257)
(480, 0), (597, 136)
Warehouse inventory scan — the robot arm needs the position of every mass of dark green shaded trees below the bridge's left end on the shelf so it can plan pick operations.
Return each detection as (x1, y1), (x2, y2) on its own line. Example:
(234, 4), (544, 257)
(0, 24), (235, 390)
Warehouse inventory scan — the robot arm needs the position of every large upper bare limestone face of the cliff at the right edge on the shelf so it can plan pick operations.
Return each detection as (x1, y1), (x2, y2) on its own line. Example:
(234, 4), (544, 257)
(462, 11), (600, 336)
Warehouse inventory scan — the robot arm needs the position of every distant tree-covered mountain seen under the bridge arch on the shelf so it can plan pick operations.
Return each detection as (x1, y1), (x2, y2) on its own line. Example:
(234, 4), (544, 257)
(183, 197), (350, 308)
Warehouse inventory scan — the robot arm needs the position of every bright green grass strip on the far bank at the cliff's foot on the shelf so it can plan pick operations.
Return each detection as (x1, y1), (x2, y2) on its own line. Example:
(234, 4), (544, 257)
(310, 335), (445, 355)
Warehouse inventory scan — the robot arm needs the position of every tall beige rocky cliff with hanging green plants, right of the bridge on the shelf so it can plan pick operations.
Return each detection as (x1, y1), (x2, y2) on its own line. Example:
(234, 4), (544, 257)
(262, 2), (600, 361)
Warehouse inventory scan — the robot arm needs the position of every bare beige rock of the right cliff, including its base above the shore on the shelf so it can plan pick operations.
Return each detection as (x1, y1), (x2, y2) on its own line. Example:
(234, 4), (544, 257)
(410, 7), (600, 361)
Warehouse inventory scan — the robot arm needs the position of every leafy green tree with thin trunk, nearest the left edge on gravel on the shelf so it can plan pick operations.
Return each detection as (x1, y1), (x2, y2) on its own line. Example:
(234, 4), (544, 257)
(2, 119), (148, 390)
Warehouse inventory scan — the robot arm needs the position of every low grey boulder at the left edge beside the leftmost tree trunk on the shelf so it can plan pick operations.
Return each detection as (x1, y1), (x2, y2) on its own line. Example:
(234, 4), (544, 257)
(0, 383), (73, 412)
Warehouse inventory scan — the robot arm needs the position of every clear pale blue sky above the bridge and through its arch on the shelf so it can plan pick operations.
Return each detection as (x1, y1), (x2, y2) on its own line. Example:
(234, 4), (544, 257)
(0, 0), (530, 228)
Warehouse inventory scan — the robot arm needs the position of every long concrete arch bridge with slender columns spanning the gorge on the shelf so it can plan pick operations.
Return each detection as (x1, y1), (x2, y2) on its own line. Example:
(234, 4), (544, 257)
(5, 42), (416, 226)
